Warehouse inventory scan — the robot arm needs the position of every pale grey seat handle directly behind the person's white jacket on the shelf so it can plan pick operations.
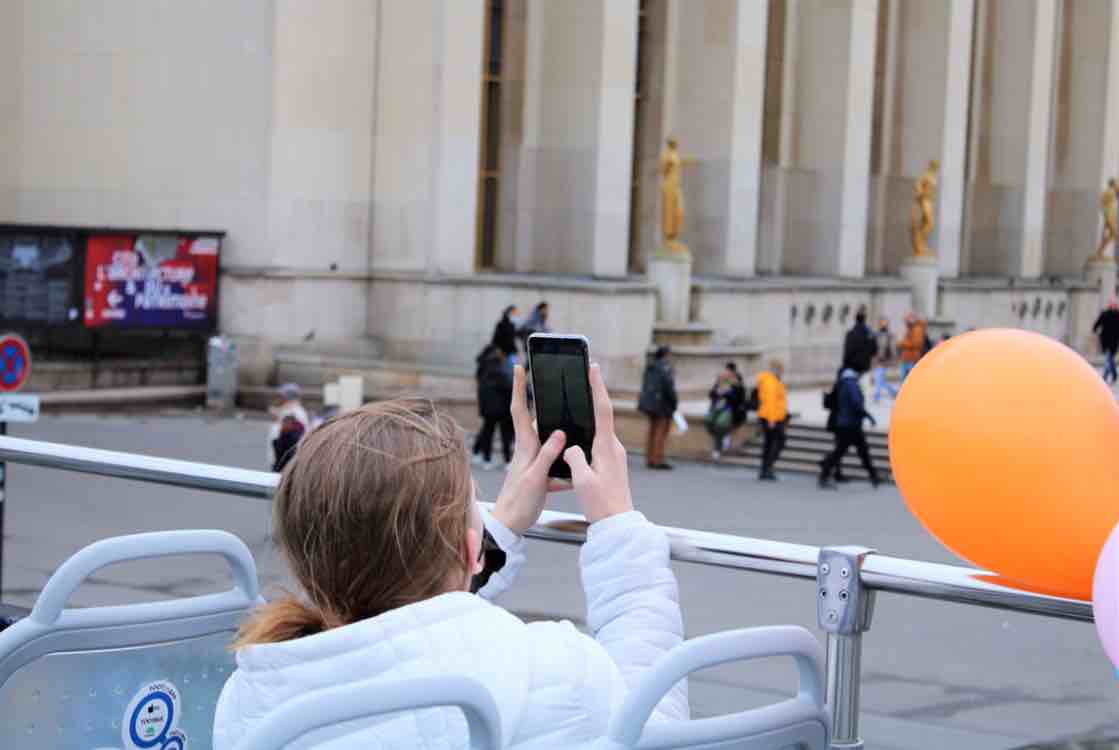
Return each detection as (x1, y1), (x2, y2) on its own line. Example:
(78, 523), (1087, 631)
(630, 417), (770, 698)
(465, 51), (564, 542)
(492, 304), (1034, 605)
(237, 676), (501, 750)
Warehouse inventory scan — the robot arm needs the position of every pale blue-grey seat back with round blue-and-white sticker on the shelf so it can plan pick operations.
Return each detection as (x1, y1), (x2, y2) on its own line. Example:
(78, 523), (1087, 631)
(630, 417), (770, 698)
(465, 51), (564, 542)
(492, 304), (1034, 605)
(0, 531), (262, 750)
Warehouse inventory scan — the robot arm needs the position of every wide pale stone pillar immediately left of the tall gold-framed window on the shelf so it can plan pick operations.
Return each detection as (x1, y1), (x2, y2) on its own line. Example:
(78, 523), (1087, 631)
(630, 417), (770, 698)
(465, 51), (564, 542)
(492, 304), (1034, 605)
(371, 0), (486, 274)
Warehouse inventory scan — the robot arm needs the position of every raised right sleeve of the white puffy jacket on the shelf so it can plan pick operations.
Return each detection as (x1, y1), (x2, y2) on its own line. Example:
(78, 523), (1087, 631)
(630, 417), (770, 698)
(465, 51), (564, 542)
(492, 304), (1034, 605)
(580, 510), (688, 719)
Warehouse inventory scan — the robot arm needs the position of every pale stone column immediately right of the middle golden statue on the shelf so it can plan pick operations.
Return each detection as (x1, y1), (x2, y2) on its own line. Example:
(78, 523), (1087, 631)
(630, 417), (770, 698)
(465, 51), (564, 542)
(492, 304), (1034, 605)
(933, 0), (976, 278)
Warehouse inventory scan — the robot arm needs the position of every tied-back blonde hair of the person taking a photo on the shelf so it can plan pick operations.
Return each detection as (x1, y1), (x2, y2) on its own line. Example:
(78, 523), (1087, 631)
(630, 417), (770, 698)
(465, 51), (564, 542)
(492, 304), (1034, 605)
(233, 399), (473, 649)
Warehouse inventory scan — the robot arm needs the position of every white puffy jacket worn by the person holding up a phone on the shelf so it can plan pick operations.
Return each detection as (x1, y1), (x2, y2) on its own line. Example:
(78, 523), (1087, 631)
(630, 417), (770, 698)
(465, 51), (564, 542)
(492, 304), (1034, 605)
(214, 512), (688, 750)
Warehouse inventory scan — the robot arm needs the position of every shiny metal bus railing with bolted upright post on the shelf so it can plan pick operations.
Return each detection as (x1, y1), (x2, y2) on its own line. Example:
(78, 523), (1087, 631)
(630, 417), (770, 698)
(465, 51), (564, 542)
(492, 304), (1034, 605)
(0, 438), (1092, 748)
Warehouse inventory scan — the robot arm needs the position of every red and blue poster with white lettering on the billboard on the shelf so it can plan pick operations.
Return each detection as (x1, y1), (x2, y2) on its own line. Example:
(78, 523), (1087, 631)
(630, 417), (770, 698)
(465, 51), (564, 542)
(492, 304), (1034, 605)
(85, 234), (220, 329)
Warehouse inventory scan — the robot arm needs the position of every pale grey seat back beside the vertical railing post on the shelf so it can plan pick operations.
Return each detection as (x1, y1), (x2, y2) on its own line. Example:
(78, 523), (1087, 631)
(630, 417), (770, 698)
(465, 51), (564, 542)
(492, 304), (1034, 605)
(606, 626), (830, 750)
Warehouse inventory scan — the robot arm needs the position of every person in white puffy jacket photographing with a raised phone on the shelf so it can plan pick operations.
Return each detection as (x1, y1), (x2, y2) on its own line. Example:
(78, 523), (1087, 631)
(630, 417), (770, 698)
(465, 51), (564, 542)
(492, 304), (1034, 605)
(214, 365), (688, 750)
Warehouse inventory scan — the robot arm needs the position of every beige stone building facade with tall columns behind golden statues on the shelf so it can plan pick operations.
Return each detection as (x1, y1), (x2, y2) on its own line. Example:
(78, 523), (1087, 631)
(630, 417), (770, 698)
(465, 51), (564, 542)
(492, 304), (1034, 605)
(0, 0), (1119, 390)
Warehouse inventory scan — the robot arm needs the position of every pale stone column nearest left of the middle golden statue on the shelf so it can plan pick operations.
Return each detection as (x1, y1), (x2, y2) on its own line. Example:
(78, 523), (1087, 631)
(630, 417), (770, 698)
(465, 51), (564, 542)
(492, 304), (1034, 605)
(836, 0), (878, 278)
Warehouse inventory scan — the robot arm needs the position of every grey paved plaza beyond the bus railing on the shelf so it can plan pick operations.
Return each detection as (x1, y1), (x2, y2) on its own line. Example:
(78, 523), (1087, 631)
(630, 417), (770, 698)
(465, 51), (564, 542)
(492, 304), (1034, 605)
(3, 413), (1119, 750)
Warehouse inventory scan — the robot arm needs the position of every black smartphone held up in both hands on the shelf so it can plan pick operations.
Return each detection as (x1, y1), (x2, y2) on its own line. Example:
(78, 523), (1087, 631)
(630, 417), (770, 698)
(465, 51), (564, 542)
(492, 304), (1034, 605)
(528, 334), (594, 479)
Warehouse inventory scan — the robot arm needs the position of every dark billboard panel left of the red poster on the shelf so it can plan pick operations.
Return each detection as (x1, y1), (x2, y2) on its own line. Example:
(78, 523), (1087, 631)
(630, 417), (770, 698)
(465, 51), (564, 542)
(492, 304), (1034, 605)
(0, 227), (79, 326)
